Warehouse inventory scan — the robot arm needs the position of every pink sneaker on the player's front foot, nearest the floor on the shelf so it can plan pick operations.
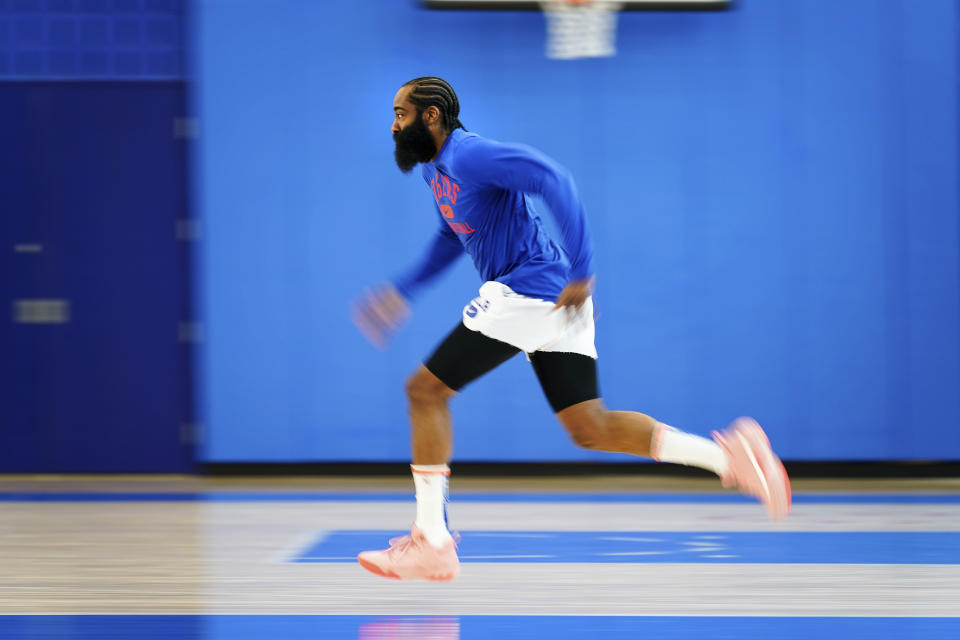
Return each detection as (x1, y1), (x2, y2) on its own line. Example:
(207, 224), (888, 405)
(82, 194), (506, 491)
(357, 525), (460, 582)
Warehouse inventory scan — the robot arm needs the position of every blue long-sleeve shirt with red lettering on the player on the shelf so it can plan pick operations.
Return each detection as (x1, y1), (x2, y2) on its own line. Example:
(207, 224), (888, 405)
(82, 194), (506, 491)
(394, 129), (593, 300)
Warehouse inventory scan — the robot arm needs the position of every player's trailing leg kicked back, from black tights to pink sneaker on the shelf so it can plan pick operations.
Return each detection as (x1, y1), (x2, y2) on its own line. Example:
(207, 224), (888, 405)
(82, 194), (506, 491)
(530, 351), (790, 519)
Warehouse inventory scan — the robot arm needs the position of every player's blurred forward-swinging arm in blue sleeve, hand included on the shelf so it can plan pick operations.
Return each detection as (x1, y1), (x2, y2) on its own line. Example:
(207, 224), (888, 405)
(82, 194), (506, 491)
(352, 220), (463, 348)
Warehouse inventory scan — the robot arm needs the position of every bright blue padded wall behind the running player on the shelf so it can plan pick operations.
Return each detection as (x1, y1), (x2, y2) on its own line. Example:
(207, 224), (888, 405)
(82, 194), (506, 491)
(194, 0), (960, 462)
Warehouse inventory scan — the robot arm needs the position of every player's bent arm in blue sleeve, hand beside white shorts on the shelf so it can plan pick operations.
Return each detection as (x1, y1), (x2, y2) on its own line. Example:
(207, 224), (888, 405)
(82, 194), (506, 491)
(457, 140), (593, 306)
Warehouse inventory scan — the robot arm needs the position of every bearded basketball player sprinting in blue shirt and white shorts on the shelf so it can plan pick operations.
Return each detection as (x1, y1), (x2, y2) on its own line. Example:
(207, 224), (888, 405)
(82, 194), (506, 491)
(354, 77), (790, 581)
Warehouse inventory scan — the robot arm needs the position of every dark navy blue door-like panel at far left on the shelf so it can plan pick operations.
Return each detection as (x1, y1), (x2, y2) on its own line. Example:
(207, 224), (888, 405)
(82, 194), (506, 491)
(0, 82), (193, 472)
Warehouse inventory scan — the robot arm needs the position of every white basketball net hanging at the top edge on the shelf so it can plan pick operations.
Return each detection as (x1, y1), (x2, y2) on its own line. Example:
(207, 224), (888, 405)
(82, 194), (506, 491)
(540, 0), (620, 60)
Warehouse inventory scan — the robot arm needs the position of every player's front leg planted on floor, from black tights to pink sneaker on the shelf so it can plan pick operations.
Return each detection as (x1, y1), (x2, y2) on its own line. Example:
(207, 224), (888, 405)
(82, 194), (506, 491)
(357, 324), (520, 581)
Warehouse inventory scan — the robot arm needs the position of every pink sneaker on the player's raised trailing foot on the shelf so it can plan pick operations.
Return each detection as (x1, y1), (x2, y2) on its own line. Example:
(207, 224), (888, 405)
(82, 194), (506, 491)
(713, 418), (791, 520)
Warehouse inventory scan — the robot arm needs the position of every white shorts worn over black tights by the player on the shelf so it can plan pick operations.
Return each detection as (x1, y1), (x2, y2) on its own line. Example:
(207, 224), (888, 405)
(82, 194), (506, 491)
(463, 282), (597, 359)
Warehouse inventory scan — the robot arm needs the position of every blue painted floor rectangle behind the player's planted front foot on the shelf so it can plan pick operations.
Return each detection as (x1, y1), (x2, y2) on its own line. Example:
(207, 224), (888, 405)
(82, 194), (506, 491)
(291, 531), (960, 564)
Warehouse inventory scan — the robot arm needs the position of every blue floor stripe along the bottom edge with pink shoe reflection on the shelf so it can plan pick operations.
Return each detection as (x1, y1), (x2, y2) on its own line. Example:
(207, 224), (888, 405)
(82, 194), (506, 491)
(0, 615), (960, 640)
